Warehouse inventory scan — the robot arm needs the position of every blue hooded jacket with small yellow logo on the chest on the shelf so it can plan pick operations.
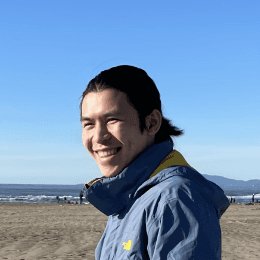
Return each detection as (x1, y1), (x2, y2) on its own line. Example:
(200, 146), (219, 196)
(86, 141), (229, 260)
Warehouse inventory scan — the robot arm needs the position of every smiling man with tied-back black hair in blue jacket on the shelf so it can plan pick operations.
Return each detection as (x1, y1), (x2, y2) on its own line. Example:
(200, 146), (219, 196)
(80, 66), (229, 260)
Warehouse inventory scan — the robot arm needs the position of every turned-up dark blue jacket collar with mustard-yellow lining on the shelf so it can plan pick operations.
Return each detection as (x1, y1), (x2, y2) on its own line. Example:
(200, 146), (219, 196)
(85, 141), (193, 216)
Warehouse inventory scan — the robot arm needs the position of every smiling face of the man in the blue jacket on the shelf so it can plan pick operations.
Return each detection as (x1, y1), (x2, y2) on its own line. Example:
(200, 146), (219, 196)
(82, 89), (151, 177)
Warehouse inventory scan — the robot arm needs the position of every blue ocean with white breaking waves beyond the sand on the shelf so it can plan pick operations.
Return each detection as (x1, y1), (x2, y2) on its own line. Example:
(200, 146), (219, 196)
(0, 184), (260, 204)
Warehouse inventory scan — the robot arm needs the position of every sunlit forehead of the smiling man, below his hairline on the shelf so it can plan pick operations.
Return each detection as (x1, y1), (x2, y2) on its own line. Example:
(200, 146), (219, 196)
(82, 89), (135, 117)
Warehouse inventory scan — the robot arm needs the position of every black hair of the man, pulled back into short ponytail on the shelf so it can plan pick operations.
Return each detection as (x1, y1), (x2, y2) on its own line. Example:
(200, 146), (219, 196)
(80, 65), (184, 145)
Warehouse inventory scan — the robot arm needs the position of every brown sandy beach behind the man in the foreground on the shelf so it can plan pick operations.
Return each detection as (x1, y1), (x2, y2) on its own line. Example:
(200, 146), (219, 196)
(0, 203), (260, 260)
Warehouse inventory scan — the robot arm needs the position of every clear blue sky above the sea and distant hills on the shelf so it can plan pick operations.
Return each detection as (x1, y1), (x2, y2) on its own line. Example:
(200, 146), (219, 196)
(0, 0), (260, 184)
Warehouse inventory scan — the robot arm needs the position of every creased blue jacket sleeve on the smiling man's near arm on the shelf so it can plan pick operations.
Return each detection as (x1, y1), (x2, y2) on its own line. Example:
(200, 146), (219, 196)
(147, 197), (221, 260)
